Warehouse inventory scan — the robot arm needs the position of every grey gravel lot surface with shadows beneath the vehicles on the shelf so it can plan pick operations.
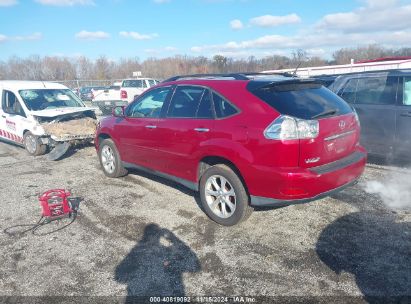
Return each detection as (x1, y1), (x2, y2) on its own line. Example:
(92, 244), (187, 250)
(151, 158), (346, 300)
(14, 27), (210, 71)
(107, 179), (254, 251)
(0, 142), (411, 302)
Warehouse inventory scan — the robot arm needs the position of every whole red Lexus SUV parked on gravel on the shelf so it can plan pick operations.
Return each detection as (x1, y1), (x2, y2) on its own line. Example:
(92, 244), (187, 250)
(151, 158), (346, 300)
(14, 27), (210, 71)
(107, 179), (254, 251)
(95, 74), (367, 226)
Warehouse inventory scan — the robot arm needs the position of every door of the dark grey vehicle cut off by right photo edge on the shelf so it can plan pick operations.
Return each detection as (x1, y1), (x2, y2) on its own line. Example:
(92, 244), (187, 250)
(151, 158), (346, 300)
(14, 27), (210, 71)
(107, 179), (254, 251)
(395, 77), (411, 160)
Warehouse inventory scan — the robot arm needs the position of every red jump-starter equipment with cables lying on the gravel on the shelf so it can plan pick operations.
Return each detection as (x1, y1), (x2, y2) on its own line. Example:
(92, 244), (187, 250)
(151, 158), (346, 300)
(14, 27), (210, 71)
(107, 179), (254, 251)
(39, 189), (75, 221)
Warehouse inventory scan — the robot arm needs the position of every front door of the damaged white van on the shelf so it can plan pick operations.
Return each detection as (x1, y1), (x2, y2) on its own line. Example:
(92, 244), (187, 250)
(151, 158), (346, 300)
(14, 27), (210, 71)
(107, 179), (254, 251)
(0, 90), (27, 144)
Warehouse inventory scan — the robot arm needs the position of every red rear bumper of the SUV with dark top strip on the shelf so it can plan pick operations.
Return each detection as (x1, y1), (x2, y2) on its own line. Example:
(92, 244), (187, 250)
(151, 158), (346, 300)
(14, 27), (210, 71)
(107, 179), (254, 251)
(250, 148), (367, 206)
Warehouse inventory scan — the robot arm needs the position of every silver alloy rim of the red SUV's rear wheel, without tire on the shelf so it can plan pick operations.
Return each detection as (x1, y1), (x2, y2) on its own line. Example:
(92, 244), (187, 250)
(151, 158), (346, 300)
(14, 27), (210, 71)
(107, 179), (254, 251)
(205, 175), (237, 219)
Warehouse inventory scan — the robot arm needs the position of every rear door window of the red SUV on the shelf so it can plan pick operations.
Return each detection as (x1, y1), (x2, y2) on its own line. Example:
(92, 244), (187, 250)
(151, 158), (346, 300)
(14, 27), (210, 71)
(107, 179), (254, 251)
(167, 86), (212, 118)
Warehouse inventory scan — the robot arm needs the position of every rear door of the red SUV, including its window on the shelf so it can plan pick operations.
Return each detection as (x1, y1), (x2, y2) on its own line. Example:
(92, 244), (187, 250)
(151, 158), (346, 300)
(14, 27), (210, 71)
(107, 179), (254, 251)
(157, 85), (214, 180)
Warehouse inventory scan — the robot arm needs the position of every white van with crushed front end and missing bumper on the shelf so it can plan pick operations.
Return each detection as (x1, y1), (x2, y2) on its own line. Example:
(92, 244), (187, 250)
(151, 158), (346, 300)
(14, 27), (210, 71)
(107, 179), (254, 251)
(0, 80), (97, 160)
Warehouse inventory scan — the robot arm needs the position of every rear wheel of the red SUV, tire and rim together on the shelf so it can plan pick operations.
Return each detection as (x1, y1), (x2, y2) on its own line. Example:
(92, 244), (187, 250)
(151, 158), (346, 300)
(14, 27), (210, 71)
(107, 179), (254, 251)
(199, 164), (253, 226)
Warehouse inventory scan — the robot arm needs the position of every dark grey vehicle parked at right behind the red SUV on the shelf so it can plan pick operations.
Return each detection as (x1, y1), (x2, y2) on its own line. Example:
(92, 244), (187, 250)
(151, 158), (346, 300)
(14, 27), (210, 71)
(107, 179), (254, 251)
(330, 69), (411, 160)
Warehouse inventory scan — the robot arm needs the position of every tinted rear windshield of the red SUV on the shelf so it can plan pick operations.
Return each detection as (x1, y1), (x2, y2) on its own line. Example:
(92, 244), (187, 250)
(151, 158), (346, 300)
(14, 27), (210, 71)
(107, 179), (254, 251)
(252, 82), (352, 119)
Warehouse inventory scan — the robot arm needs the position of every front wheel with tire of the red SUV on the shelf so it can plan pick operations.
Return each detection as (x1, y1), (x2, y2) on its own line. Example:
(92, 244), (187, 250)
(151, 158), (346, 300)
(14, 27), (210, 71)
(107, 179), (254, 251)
(98, 139), (127, 178)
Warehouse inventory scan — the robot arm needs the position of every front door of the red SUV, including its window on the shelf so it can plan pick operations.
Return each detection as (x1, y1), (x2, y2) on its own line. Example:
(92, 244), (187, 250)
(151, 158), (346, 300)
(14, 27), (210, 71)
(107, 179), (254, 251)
(115, 87), (171, 171)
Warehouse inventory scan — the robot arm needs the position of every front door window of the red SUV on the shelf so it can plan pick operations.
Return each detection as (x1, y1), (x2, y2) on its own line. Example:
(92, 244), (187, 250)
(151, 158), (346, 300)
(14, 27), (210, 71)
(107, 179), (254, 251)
(126, 87), (171, 118)
